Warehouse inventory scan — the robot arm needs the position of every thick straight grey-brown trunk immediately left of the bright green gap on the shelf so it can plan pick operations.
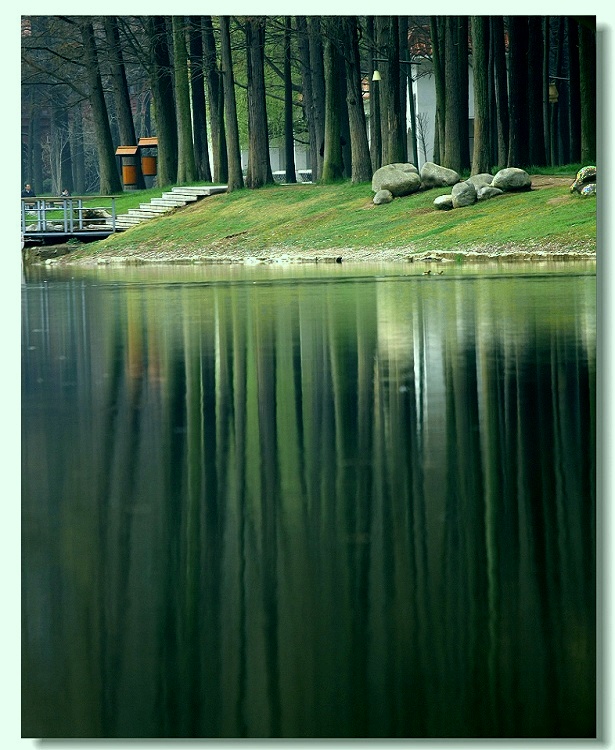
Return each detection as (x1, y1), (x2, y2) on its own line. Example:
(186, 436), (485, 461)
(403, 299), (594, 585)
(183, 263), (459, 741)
(245, 16), (273, 188)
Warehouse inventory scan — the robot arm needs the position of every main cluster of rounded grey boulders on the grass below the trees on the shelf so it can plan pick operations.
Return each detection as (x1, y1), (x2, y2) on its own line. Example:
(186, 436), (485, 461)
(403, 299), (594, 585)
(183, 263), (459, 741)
(372, 161), (532, 211)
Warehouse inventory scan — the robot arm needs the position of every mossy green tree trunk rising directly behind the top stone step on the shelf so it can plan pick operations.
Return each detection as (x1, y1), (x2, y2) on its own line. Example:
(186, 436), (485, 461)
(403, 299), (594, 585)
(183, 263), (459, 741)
(172, 16), (197, 185)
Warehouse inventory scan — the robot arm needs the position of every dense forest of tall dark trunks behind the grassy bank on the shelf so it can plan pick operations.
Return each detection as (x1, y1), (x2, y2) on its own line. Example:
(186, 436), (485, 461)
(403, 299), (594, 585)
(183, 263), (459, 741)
(21, 15), (596, 195)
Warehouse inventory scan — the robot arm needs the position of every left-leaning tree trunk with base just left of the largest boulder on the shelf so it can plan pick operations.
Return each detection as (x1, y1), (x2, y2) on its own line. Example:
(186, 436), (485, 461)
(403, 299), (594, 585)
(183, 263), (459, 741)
(342, 16), (372, 183)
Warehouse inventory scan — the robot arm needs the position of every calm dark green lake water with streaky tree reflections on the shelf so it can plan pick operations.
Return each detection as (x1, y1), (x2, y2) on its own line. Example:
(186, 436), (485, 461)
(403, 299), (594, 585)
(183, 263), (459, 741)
(22, 262), (596, 738)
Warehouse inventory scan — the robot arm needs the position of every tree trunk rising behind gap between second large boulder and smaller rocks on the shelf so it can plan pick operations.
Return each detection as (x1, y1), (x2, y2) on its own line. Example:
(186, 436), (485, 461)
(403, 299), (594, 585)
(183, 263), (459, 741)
(443, 16), (462, 172)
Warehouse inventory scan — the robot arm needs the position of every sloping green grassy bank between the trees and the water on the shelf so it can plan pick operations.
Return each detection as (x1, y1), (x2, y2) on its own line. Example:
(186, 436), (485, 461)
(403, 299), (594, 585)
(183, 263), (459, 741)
(57, 173), (596, 261)
